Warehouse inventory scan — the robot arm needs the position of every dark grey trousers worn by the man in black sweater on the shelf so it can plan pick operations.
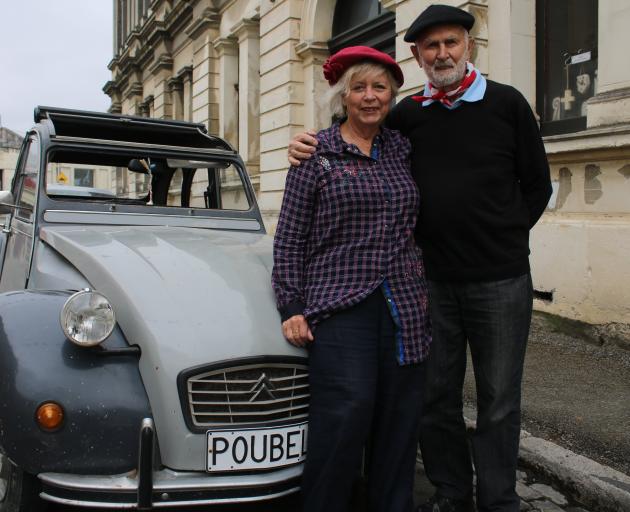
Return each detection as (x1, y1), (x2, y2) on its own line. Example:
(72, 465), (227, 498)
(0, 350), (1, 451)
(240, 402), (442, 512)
(420, 274), (532, 512)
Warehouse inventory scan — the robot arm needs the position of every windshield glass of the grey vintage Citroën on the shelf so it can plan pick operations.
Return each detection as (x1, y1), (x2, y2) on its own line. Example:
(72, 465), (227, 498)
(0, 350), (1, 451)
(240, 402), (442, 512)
(46, 150), (251, 210)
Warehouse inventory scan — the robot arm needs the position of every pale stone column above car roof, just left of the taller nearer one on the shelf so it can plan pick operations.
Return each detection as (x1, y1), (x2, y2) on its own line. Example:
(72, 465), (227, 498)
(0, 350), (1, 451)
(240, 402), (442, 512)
(212, 37), (239, 148)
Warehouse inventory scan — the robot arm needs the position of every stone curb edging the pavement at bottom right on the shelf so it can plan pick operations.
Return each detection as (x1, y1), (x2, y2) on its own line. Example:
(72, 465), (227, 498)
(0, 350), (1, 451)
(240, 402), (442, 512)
(464, 406), (630, 512)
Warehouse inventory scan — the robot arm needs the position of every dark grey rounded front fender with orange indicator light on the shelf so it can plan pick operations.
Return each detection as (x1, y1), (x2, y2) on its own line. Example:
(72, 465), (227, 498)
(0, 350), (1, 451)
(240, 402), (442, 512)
(0, 290), (151, 474)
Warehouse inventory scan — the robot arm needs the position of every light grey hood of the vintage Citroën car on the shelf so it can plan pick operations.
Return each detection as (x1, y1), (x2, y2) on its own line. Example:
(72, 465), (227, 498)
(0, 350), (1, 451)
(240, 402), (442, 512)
(40, 226), (305, 468)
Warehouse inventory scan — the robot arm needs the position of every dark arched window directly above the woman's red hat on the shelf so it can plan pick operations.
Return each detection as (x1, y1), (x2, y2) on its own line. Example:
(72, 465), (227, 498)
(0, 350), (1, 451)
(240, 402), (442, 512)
(328, 0), (396, 58)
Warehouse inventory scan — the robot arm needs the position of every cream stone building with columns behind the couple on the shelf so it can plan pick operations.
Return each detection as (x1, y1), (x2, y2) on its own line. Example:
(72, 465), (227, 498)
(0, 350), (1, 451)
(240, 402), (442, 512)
(104, 0), (630, 324)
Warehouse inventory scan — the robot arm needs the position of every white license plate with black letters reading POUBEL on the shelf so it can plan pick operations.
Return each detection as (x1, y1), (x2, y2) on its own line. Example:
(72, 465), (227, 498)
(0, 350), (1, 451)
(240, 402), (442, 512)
(207, 423), (308, 471)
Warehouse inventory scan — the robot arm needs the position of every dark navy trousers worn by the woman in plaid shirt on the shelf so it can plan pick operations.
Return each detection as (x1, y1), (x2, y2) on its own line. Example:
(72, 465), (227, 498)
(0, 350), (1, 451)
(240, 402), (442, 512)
(302, 289), (423, 512)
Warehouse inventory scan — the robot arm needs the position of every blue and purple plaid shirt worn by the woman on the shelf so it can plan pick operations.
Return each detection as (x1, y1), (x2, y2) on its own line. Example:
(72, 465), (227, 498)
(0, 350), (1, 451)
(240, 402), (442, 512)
(272, 123), (431, 364)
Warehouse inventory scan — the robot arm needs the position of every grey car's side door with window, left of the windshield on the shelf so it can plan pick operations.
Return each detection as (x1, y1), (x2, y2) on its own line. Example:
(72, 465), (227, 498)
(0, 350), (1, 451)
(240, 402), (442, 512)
(0, 134), (40, 292)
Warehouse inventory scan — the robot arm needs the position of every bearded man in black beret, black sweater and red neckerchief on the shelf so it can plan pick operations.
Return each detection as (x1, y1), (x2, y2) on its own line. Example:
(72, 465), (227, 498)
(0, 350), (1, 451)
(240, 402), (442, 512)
(290, 5), (551, 512)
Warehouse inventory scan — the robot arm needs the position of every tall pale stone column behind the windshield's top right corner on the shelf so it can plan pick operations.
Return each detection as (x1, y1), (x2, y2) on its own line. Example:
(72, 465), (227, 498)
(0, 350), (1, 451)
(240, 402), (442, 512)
(232, 17), (260, 180)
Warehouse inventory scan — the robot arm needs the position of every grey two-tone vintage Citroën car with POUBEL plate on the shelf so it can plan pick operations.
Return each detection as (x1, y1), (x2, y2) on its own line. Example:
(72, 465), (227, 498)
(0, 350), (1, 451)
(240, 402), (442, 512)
(0, 107), (308, 512)
